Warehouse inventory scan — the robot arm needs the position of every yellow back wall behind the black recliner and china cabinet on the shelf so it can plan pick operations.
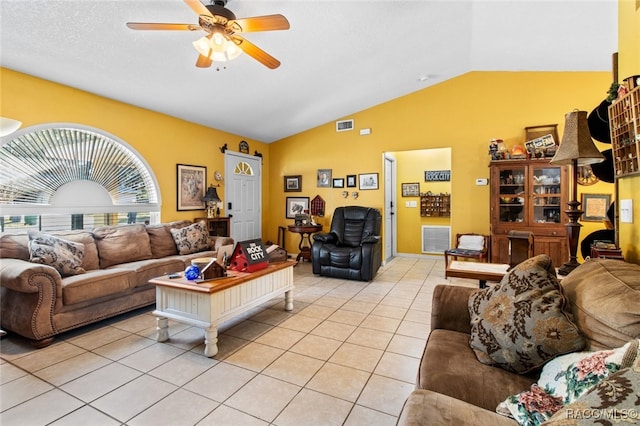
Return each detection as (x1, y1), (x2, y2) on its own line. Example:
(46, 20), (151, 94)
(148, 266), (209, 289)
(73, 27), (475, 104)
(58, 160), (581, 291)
(265, 72), (613, 256)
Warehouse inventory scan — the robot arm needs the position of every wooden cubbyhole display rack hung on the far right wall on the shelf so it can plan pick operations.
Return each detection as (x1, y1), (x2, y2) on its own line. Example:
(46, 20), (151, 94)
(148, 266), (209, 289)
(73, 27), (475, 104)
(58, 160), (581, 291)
(609, 87), (640, 178)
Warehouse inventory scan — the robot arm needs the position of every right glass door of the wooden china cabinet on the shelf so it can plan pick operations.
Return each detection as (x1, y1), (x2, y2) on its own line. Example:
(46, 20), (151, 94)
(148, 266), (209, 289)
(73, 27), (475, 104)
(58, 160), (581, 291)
(531, 166), (562, 225)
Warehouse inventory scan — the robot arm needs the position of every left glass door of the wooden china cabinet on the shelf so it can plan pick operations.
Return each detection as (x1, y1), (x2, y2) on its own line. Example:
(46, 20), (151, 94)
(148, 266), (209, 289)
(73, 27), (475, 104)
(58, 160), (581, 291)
(499, 166), (527, 222)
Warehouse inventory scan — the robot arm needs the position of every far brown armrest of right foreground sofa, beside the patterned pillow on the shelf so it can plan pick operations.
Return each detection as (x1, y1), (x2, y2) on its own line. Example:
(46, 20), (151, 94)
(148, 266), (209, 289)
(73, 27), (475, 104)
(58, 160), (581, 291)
(431, 284), (478, 334)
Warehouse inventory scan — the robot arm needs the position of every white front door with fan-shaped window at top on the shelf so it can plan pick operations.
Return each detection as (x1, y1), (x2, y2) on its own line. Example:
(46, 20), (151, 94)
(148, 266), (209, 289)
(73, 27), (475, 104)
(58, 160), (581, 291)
(224, 151), (262, 241)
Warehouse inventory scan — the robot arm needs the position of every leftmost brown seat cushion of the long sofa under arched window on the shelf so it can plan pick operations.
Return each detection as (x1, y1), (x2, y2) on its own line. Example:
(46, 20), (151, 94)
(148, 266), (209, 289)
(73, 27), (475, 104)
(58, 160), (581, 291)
(62, 269), (134, 305)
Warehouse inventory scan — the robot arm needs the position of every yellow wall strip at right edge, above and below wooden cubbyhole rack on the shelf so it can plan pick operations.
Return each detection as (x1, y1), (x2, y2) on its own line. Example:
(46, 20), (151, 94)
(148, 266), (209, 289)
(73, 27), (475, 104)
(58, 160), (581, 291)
(618, 0), (640, 263)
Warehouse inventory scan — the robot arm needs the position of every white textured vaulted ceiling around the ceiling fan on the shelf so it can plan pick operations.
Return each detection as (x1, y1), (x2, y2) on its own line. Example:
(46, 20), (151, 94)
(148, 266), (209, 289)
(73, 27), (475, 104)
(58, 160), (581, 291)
(0, 0), (618, 143)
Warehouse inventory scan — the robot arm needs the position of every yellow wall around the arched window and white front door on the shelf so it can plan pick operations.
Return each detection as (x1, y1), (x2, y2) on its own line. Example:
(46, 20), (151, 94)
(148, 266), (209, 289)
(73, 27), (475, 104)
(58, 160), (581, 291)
(0, 68), (270, 222)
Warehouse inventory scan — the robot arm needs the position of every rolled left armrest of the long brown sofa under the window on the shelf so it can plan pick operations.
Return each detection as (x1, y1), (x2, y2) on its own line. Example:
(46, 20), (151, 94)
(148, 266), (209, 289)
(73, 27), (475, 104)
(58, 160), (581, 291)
(0, 259), (62, 341)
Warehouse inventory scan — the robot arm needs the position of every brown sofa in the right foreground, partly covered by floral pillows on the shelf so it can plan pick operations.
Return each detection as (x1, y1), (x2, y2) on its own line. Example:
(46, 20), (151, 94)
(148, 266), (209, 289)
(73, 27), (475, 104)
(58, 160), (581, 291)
(398, 259), (640, 426)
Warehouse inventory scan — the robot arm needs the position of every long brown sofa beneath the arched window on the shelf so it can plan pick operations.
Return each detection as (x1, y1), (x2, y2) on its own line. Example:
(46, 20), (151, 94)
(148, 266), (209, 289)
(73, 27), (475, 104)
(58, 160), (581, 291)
(0, 221), (233, 346)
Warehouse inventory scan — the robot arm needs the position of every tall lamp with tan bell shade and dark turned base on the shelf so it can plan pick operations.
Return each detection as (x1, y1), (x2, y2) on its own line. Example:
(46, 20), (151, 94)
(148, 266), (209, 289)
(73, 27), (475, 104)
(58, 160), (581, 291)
(551, 110), (604, 275)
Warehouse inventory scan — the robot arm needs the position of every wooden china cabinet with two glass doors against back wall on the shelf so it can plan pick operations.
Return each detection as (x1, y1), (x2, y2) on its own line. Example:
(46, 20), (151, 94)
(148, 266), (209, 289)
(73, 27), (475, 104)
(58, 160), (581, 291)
(490, 159), (569, 267)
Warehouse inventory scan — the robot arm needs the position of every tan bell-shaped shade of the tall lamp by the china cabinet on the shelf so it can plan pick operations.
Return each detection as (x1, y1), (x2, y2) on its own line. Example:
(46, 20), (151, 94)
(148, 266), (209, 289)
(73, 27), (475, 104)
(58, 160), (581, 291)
(551, 110), (604, 166)
